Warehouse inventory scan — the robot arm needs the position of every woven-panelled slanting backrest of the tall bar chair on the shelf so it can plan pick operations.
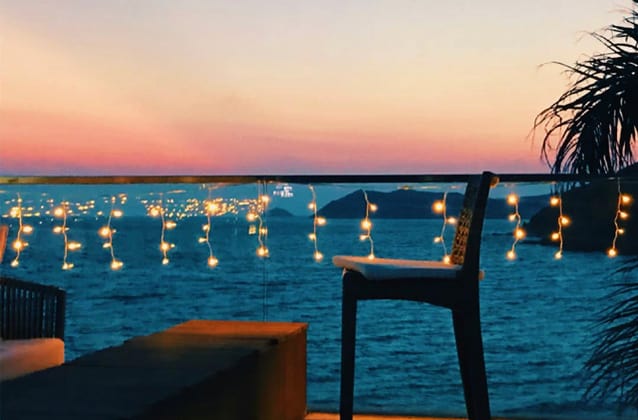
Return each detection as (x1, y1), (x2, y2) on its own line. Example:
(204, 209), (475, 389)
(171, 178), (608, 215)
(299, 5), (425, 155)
(450, 172), (498, 273)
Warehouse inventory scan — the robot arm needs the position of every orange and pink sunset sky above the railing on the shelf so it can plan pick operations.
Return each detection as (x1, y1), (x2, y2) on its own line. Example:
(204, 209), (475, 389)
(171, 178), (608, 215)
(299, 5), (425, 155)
(0, 0), (631, 175)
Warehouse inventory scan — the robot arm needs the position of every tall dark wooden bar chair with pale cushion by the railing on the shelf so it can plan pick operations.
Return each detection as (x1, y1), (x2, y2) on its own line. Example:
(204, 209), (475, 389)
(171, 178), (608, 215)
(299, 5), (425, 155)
(333, 172), (498, 420)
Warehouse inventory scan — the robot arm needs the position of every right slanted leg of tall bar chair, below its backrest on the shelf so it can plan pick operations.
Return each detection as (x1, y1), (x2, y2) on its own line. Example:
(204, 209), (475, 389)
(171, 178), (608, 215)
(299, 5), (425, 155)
(452, 307), (491, 420)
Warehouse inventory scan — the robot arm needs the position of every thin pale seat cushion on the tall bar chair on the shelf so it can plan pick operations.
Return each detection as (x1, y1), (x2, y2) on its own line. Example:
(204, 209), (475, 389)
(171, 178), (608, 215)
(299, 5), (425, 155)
(332, 255), (462, 280)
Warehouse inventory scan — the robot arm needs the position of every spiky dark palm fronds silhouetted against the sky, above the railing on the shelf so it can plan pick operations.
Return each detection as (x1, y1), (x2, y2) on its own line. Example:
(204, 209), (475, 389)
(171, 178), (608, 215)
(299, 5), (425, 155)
(534, 0), (638, 175)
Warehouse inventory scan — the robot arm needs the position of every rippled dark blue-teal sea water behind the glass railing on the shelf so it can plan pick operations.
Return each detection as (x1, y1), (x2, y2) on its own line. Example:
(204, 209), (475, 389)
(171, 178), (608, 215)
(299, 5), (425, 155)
(1, 217), (638, 419)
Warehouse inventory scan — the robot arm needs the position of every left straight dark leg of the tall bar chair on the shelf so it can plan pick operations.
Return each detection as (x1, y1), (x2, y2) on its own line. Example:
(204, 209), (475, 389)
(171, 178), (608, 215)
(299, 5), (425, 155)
(339, 272), (357, 420)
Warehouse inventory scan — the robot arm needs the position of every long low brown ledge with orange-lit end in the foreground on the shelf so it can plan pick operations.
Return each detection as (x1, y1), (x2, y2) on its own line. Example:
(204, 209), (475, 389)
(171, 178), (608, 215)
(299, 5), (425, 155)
(0, 321), (307, 420)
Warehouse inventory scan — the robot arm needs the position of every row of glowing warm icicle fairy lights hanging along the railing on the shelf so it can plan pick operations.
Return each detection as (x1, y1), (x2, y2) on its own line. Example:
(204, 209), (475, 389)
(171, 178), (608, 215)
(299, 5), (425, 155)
(1, 185), (633, 271)
